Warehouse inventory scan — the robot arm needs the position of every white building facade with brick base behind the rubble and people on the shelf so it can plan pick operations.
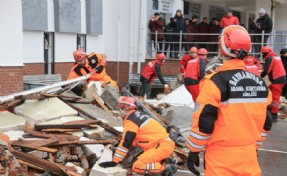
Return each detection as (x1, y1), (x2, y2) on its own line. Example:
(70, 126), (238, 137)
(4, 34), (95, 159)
(0, 0), (287, 96)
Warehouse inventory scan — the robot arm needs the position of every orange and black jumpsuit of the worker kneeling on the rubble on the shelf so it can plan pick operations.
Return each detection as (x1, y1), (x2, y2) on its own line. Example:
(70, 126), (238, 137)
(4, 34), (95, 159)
(113, 110), (175, 174)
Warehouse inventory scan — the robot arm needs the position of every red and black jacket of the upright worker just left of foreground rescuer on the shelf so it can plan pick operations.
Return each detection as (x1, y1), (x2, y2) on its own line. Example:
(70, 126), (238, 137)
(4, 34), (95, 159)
(184, 57), (206, 86)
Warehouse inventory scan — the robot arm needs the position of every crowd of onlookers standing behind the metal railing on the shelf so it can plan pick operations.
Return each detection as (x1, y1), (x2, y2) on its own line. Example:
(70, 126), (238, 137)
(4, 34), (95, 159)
(149, 9), (273, 58)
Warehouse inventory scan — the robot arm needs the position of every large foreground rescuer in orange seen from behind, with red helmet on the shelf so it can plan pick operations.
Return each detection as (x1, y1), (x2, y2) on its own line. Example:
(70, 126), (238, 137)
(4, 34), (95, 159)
(186, 25), (272, 176)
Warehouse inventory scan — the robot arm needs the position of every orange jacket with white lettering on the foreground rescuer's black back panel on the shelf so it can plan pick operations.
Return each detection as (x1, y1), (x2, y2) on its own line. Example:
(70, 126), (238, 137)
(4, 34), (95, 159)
(186, 59), (272, 152)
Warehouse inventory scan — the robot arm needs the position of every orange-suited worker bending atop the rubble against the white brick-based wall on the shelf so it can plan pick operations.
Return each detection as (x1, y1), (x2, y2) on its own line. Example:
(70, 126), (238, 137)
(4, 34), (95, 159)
(67, 50), (118, 95)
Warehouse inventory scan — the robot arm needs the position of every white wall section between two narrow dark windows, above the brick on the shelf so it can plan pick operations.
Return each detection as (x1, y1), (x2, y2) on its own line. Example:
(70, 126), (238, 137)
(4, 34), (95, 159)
(54, 32), (77, 62)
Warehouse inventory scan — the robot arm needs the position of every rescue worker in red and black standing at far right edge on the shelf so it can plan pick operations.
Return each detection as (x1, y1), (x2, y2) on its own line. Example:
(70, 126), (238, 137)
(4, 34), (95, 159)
(261, 46), (286, 122)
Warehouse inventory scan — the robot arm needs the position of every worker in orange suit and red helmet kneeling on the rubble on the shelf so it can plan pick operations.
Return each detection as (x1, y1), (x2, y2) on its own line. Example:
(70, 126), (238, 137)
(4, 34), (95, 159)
(100, 96), (176, 175)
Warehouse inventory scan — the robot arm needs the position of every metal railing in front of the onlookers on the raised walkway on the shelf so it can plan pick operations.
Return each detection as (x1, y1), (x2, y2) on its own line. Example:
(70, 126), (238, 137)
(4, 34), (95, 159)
(147, 30), (287, 60)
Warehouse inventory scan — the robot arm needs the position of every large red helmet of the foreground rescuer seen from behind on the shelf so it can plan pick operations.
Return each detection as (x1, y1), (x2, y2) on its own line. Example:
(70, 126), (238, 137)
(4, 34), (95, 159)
(219, 25), (251, 58)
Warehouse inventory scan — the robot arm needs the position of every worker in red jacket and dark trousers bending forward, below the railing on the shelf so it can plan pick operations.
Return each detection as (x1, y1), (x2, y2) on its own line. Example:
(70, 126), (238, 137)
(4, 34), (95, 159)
(140, 53), (170, 99)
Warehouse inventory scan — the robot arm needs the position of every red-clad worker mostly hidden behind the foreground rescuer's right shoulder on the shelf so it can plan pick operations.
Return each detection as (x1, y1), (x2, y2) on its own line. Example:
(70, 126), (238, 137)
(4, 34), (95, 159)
(243, 55), (262, 76)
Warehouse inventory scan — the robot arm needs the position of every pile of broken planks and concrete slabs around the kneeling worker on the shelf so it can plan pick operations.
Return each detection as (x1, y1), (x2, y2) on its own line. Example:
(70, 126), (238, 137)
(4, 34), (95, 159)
(0, 78), (196, 176)
